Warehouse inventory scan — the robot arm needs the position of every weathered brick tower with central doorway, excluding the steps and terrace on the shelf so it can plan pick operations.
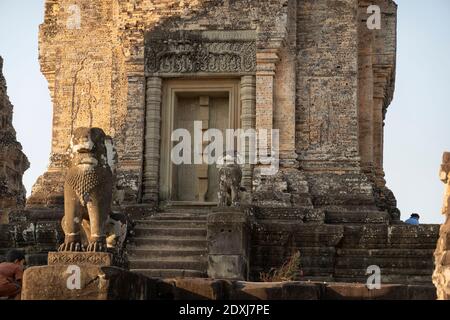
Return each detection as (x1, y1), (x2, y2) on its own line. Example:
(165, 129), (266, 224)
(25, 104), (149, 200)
(28, 0), (399, 220)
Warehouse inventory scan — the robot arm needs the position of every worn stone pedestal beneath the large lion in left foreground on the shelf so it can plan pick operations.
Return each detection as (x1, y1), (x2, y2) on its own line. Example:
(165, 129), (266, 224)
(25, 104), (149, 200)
(22, 252), (151, 300)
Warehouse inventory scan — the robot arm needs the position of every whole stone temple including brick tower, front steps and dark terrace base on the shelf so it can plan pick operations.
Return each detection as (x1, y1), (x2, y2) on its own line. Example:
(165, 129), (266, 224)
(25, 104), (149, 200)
(0, 0), (438, 292)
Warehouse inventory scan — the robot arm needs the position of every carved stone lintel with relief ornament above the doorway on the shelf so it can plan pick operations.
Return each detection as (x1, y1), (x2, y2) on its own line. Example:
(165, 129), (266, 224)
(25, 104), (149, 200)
(146, 40), (256, 74)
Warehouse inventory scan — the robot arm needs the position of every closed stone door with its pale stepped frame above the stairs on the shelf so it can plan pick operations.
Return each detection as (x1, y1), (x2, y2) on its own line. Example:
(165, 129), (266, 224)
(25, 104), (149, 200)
(160, 80), (239, 203)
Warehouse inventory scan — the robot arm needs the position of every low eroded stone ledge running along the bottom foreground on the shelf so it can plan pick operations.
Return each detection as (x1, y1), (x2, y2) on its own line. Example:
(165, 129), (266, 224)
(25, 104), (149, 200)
(22, 266), (436, 301)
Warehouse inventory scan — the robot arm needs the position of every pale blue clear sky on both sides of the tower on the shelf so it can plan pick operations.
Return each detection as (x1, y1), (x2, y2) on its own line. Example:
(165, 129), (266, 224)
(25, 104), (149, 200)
(0, 0), (450, 223)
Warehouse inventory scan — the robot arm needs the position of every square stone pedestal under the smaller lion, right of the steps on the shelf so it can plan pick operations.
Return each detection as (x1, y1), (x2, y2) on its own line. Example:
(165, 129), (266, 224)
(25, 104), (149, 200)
(207, 208), (250, 280)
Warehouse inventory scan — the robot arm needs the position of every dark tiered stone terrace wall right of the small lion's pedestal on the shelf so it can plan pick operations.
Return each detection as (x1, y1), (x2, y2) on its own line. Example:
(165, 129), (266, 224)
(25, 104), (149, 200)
(250, 213), (439, 285)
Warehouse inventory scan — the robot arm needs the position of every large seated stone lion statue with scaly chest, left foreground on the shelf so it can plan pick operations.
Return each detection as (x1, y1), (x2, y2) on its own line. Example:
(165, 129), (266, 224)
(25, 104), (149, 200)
(59, 128), (126, 252)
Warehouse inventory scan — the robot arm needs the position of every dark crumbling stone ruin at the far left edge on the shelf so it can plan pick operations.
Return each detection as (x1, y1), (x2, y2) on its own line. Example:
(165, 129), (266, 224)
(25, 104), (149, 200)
(0, 57), (30, 224)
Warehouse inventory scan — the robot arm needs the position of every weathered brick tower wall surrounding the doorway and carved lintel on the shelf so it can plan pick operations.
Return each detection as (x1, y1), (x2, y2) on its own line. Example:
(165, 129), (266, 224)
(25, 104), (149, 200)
(29, 0), (396, 209)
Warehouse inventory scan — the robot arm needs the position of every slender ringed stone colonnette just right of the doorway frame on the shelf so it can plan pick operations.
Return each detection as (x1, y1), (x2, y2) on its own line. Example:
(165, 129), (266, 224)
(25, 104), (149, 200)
(241, 76), (256, 191)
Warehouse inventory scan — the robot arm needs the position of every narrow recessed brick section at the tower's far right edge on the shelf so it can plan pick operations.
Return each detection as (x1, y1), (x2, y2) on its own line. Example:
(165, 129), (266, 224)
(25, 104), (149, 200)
(358, 1), (399, 219)
